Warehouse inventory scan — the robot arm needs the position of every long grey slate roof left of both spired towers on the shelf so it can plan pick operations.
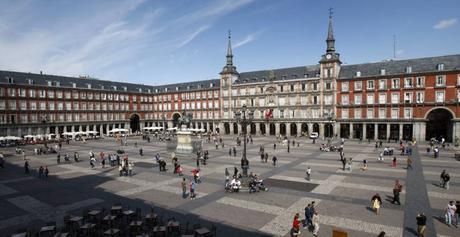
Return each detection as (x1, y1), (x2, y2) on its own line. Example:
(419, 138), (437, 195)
(0, 71), (220, 93)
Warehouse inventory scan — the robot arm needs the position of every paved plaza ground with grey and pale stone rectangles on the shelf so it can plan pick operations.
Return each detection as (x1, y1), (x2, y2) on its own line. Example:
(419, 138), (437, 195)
(0, 136), (460, 237)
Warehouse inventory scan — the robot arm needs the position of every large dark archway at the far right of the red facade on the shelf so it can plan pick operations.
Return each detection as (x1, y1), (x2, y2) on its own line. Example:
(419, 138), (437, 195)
(425, 108), (454, 142)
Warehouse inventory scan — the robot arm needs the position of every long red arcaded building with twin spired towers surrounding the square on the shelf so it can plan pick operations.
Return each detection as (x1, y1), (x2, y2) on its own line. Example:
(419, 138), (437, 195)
(0, 17), (460, 141)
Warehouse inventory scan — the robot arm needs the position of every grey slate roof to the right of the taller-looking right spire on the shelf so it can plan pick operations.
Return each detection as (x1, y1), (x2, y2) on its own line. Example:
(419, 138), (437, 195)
(339, 54), (460, 79)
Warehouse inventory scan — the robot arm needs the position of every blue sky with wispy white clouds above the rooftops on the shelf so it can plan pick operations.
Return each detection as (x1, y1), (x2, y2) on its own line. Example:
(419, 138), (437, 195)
(0, 0), (460, 85)
